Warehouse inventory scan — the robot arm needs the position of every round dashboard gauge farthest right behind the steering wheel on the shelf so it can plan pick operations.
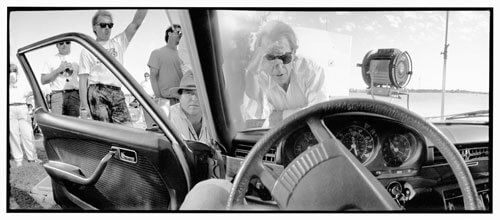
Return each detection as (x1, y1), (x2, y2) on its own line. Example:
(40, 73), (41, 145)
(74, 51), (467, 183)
(382, 134), (411, 167)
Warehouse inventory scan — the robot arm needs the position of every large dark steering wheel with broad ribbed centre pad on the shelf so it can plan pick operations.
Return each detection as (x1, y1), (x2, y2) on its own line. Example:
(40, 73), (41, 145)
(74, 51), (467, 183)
(226, 98), (482, 211)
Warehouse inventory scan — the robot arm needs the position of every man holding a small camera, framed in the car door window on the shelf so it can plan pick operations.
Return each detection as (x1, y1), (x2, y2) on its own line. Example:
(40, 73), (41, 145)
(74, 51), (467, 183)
(41, 41), (80, 117)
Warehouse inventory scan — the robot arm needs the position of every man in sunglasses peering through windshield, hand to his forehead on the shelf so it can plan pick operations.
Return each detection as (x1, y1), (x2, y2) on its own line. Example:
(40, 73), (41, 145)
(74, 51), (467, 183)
(242, 21), (328, 126)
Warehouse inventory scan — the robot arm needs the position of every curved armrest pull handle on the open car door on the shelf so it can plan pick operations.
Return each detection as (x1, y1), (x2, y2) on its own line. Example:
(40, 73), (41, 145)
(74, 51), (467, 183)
(43, 147), (116, 185)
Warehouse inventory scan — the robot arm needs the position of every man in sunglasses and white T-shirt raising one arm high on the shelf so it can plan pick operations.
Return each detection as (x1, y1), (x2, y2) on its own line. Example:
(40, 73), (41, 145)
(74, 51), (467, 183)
(79, 10), (147, 125)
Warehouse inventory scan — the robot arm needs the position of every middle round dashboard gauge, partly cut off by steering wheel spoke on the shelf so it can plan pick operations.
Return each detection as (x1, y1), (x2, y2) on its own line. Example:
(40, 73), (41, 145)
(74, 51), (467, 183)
(335, 125), (376, 163)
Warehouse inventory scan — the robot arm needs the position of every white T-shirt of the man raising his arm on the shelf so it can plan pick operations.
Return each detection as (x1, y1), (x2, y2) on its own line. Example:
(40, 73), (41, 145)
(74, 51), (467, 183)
(80, 32), (129, 87)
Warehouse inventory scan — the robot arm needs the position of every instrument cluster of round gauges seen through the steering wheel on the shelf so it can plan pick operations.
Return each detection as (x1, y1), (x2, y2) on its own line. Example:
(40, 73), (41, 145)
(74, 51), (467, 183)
(282, 115), (426, 173)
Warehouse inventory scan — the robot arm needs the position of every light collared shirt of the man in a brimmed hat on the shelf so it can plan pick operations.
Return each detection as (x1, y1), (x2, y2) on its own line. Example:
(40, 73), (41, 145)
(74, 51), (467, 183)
(169, 103), (211, 146)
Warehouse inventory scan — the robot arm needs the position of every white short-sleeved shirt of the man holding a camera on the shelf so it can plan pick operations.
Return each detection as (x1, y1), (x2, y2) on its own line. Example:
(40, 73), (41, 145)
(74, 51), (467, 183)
(42, 53), (79, 91)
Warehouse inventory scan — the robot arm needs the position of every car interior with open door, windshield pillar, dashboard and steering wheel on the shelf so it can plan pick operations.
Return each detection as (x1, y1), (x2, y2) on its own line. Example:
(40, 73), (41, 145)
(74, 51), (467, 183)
(11, 8), (493, 212)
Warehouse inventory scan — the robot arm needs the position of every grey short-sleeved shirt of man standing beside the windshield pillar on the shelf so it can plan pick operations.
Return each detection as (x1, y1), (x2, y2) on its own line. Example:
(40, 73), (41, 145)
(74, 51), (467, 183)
(148, 46), (186, 98)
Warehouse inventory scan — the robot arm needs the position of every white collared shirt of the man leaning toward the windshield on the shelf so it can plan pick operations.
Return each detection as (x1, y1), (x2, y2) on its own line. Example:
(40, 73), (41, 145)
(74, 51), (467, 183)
(242, 56), (328, 119)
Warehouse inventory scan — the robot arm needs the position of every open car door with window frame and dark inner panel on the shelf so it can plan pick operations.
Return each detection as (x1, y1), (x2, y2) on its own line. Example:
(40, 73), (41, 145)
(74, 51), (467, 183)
(17, 33), (195, 210)
